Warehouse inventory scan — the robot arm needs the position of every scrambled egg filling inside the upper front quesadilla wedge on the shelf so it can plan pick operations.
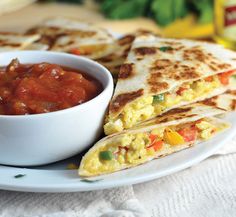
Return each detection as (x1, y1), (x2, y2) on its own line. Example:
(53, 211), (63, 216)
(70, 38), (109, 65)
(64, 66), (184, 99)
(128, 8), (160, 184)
(104, 75), (222, 135)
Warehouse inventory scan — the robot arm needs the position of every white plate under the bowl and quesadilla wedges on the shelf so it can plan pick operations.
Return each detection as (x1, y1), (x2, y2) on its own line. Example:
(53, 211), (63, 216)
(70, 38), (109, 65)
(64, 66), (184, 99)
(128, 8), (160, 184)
(0, 112), (236, 192)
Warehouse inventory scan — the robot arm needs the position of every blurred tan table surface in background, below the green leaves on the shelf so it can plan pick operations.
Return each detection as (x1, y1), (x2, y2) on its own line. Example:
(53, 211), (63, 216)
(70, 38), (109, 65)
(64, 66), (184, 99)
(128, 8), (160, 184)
(0, 3), (160, 33)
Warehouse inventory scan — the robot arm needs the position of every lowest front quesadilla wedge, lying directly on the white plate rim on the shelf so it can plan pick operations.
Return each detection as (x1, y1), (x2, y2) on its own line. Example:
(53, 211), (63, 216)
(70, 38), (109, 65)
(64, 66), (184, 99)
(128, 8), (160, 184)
(79, 103), (229, 176)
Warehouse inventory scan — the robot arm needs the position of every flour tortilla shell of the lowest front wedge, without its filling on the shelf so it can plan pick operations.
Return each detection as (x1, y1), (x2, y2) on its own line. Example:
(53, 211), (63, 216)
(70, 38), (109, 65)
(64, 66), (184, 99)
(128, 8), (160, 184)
(79, 103), (229, 176)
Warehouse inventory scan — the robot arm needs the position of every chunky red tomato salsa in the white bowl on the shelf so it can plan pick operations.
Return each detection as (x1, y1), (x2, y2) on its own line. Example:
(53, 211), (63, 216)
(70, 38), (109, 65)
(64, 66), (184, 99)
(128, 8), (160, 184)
(0, 59), (102, 115)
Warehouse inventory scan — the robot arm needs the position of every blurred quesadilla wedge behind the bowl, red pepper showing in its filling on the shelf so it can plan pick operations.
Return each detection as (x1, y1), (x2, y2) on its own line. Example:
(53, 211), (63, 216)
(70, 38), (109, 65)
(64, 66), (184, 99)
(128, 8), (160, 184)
(28, 17), (114, 59)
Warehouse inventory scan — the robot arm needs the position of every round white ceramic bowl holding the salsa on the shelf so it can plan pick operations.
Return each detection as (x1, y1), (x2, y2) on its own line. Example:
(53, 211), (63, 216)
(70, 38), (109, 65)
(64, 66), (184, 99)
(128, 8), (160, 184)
(0, 51), (113, 166)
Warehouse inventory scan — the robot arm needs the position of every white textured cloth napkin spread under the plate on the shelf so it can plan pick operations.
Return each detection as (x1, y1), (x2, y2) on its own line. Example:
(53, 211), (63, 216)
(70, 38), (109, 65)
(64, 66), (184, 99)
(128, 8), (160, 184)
(0, 137), (236, 217)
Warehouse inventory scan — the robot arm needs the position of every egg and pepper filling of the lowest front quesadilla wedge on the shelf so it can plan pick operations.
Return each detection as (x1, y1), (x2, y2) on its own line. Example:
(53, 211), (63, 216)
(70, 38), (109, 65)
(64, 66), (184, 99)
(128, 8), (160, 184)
(84, 119), (220, 174)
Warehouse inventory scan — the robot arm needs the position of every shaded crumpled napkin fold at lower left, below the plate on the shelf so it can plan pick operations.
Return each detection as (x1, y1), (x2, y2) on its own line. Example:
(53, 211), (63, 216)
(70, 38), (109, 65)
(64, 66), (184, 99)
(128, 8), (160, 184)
(0, 186), (148, 217)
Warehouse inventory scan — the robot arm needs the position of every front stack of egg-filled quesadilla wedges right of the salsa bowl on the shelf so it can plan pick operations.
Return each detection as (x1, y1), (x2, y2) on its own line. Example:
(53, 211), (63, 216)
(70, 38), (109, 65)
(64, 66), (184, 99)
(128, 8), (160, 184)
(79, 33), (236, 176)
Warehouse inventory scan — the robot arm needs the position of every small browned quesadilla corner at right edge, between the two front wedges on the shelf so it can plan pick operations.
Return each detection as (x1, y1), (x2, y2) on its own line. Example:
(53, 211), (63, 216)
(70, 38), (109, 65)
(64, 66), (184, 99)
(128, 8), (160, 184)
(203, 90), (236, 111)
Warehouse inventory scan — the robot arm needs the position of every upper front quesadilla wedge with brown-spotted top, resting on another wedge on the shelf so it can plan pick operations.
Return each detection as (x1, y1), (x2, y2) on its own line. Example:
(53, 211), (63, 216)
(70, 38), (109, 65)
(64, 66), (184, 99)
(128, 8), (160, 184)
(104, 34), (236, 135)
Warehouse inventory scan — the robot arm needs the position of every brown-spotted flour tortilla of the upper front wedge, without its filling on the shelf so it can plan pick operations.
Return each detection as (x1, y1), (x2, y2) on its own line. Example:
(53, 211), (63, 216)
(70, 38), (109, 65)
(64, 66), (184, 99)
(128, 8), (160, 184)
(108, 34), (236, 118)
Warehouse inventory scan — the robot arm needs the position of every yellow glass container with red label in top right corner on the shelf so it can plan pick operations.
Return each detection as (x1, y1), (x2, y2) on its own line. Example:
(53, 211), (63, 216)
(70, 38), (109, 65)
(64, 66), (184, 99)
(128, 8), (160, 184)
(214, 0), (236, 50)
